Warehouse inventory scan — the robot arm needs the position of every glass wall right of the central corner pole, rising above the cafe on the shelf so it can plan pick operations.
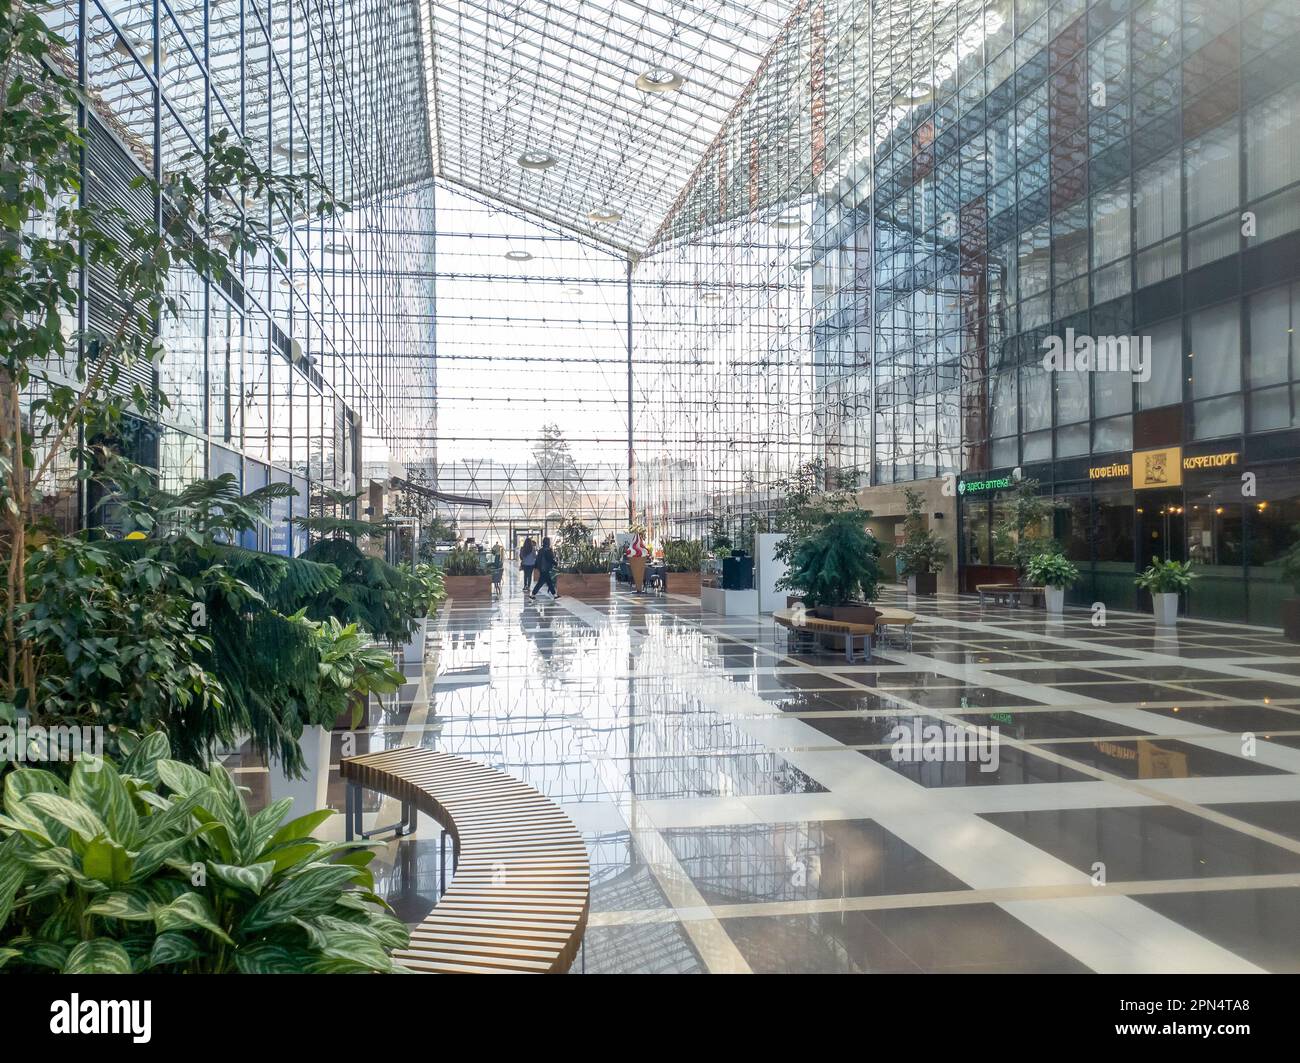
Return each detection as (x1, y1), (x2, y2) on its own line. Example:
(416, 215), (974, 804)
(637, 0), (1300, 622)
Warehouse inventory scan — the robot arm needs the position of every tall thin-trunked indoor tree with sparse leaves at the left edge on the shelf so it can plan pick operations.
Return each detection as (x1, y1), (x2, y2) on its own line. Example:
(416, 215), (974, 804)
(0, 0), (345, 716)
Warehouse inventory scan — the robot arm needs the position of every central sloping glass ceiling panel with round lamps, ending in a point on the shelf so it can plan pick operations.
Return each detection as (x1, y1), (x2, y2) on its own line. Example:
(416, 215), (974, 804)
(421, 0), (798, 253)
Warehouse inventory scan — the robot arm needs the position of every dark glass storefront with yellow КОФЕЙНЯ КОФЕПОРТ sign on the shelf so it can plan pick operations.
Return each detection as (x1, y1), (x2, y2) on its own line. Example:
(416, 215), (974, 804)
(957, 444), (1300, 626)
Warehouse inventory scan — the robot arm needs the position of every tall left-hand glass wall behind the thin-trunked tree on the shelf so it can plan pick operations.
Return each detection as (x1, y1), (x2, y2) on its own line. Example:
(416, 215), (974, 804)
(44, 0), (434, 551)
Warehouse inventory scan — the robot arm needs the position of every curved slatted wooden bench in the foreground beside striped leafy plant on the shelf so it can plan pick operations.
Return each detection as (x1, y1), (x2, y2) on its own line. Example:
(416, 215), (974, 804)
(341, 746), (592, 975)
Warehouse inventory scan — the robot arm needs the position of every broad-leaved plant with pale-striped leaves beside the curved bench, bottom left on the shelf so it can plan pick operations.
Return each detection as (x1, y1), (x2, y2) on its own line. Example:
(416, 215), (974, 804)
(0, 733), (410, 973)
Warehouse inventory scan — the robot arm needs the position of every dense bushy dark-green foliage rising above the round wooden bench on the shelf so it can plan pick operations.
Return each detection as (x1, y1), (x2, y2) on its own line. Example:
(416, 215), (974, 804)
(776, 507), (880, 624)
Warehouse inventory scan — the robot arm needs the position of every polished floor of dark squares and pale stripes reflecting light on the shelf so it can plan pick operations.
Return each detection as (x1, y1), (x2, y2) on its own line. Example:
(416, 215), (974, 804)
(238, 571), (1300, 973)
